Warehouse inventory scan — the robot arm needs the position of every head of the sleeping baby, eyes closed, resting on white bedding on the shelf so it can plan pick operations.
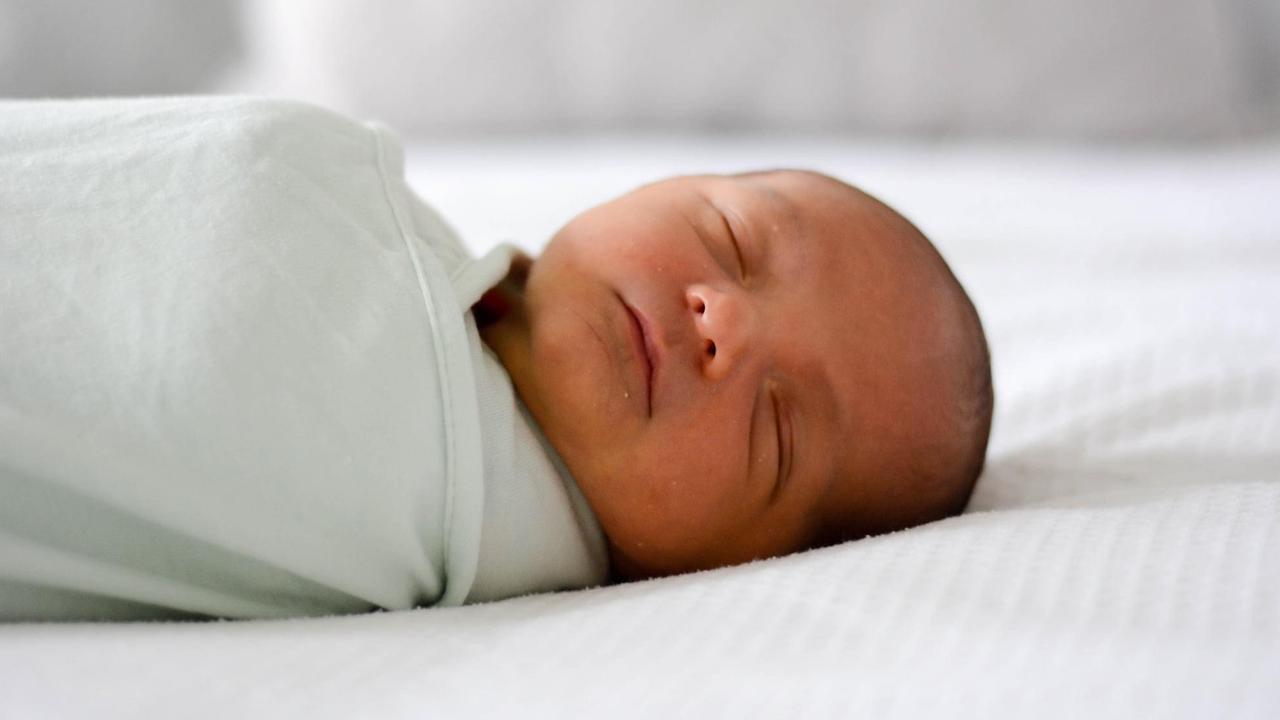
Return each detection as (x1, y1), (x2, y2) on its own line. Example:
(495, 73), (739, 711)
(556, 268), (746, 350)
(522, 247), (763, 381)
(486, 170), (992, 579)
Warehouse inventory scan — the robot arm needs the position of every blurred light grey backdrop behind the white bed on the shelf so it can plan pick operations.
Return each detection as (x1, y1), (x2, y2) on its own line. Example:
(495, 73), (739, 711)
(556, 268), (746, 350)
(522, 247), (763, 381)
(0, 0), (1280, 143)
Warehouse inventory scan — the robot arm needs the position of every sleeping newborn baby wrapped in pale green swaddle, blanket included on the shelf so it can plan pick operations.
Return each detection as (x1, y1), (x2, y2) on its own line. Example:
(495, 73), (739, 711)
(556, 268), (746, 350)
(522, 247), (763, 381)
(0, 97), (992, 620)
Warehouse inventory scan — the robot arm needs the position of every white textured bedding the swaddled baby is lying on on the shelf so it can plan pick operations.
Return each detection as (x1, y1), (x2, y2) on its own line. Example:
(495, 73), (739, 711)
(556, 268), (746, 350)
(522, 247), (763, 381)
(0, 138), (1280, 719)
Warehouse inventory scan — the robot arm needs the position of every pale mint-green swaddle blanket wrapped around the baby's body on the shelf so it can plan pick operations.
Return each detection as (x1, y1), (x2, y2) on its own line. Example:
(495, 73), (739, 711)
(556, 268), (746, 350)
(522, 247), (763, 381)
(0, 99), (607, 619)
